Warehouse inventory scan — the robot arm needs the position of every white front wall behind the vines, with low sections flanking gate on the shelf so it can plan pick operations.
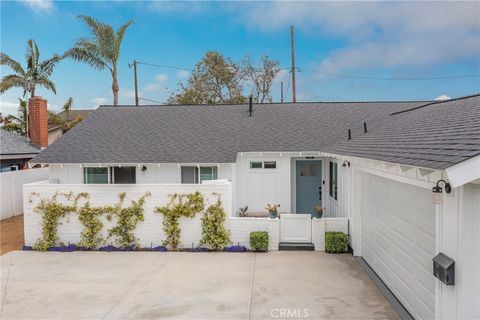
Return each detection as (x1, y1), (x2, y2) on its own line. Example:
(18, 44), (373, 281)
(23, 180), (348, 251)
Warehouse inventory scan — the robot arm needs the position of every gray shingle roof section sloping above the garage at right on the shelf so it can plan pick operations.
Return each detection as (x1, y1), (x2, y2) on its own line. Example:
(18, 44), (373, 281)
(328, 95), (480, 169)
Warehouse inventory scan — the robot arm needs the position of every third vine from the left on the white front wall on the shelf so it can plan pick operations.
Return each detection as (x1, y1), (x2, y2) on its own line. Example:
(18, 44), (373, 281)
(104, 192), (151, 249)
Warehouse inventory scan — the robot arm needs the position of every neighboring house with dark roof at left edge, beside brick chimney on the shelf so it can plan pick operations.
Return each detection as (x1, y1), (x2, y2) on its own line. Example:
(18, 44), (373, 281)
(0, 129), (40, 172)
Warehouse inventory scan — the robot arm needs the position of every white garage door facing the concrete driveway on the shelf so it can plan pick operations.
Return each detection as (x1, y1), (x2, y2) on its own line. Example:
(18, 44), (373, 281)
(362, 173), (435, 319)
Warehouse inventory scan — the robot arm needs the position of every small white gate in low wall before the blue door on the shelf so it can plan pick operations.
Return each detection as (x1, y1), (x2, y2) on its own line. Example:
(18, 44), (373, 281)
(280, 214), (312, 243)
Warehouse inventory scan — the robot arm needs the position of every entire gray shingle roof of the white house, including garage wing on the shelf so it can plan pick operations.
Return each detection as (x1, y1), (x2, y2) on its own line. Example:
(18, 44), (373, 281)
(32, 96), (480, 168)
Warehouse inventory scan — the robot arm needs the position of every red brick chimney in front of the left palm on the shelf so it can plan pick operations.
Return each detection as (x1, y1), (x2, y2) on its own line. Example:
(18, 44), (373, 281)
(28, 97), (48, 149)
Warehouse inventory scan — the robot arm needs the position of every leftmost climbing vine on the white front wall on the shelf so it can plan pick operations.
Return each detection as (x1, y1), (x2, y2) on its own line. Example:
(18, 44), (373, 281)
(29, 192), (88, 251)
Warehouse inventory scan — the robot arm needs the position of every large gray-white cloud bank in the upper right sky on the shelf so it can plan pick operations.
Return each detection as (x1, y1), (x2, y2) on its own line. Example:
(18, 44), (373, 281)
(231, 2), (480, 72)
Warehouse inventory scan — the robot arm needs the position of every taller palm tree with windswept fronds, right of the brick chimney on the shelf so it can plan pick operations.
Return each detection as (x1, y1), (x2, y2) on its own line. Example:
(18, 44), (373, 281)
(65, 16), (133, 106)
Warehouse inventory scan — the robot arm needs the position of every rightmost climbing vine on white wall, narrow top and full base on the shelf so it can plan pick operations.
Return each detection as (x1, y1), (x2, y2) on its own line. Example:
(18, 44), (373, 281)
(200, 195), (232, 250)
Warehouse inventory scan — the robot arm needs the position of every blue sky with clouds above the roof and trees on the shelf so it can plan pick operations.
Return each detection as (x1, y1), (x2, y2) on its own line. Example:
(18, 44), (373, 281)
(0, 0), (480, 114)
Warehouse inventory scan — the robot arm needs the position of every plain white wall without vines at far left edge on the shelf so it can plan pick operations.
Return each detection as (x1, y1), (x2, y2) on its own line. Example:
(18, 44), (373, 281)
(0, 168), (48, 219)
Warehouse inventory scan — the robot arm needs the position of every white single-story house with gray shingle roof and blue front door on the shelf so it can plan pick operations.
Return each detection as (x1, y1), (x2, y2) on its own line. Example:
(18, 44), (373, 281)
(25, 94), (480, 319)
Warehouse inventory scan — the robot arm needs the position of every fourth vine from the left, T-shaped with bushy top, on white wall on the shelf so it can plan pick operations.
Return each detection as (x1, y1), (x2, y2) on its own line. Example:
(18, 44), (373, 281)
(154, 191), (205, 250)
